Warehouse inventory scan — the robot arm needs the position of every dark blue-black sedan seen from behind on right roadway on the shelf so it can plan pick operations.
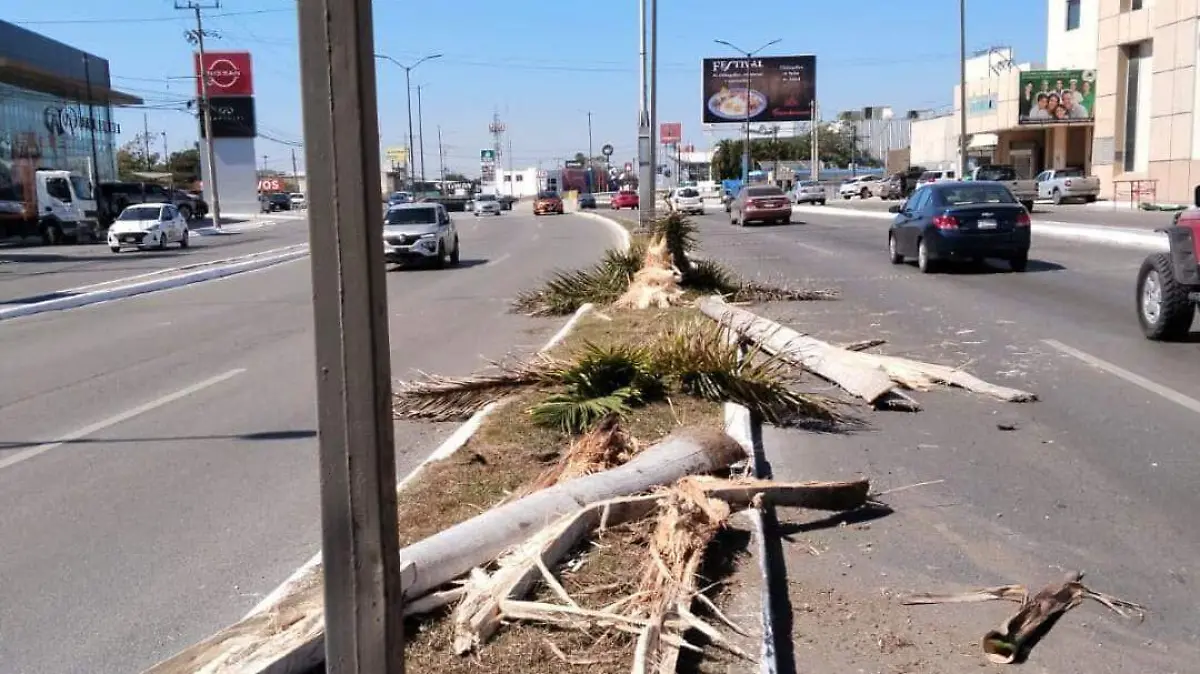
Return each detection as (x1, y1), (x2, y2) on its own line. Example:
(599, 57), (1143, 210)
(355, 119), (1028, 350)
(888, 181), (1031, 273)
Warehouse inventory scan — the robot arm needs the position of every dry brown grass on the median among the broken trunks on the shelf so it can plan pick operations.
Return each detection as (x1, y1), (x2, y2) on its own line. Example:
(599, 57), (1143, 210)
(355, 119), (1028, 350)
(398, 308), (722, 674)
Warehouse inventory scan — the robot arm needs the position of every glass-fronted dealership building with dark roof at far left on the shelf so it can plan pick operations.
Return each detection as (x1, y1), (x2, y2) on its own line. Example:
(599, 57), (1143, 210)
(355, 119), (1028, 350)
(0, 20), (142, 185)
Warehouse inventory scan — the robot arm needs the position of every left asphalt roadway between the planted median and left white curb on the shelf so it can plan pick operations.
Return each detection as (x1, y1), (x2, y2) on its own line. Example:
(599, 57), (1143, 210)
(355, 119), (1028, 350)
(0, 207), (613, 674)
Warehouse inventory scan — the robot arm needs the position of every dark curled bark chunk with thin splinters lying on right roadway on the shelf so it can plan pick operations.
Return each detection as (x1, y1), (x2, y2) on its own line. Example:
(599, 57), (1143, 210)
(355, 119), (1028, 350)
(902, 571), (1146, 664)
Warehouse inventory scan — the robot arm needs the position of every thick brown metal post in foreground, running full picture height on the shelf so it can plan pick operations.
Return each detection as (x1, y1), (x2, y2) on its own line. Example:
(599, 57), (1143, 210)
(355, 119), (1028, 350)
(298, 0), (404, 674)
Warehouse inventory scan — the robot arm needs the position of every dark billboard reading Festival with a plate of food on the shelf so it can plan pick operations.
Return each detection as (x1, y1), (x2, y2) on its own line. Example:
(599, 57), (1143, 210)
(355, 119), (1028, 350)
(701, 54), (817, 124)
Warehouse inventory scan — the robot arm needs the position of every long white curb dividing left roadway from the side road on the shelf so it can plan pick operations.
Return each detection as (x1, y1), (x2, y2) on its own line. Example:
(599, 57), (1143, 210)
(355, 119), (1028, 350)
(0, 243), (308, 320)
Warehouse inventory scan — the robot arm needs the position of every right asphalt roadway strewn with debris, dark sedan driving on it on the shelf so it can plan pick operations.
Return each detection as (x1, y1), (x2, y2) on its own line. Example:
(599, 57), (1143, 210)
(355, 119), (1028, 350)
(701, 207), (1200, 674)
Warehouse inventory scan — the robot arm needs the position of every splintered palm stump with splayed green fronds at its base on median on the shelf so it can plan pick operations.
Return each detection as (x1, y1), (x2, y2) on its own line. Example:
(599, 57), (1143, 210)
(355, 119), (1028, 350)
(512, 213), (838, 315)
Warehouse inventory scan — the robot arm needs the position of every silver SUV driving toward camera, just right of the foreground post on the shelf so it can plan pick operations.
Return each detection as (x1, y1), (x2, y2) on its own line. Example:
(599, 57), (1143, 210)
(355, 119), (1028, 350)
(383, 204), (462, 269)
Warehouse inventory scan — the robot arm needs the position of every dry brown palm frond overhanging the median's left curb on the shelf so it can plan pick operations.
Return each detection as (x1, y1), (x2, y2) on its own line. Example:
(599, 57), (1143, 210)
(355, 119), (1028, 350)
(391, 356), (563, 421)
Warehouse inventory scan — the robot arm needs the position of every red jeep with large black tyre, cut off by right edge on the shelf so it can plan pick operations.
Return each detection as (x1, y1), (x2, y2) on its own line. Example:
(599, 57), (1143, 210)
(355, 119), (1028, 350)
(1138, 187), (1200, 341)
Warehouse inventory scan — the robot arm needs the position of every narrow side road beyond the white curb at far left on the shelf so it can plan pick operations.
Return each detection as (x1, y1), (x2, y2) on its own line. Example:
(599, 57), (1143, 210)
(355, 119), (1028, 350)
(0, 215), (308, 307)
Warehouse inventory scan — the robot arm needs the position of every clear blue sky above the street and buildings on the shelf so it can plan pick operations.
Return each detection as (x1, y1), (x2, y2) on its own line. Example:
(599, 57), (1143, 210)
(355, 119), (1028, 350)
(16, 0), (1046, 173)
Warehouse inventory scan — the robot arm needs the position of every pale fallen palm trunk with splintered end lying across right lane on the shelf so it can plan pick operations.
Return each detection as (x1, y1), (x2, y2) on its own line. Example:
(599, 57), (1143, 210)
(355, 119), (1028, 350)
(697, 297), (1037, 405)
